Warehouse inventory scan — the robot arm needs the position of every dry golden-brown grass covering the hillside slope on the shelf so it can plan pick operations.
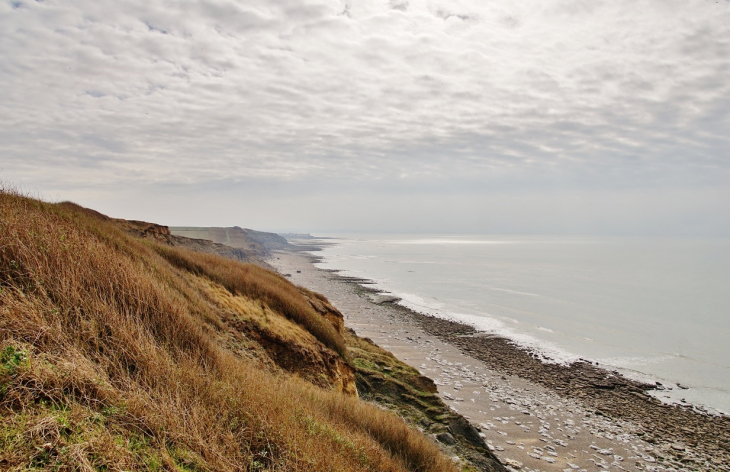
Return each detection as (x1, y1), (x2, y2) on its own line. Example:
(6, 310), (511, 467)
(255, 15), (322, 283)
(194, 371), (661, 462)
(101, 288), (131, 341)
(0, 190), (455, 471)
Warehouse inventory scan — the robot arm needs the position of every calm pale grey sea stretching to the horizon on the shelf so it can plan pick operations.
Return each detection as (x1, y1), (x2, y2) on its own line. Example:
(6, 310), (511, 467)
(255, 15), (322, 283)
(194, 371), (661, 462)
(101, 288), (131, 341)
(308, 234), (730, 413)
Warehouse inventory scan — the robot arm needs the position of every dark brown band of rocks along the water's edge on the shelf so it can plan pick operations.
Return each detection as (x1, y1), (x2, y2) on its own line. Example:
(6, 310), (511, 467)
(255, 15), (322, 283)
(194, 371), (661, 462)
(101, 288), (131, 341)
(394, 300), (730, 470)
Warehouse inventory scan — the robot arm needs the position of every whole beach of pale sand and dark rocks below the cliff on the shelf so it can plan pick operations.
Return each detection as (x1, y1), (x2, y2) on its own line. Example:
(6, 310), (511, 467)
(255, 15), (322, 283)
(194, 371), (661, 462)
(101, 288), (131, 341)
(269, 246), (730, 471)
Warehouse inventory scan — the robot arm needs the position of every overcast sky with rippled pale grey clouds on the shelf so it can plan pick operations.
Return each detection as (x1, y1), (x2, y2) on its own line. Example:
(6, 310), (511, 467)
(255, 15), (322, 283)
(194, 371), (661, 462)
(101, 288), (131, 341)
(0, 0), (730, 237)
